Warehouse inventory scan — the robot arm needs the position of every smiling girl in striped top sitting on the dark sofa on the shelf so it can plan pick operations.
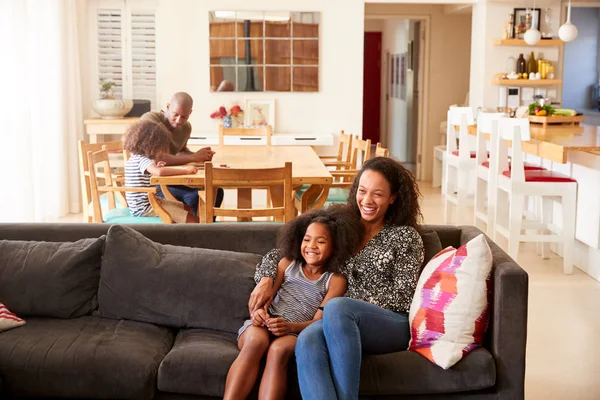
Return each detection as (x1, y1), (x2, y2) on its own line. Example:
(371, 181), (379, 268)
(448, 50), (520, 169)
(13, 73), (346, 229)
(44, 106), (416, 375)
(224, 206), (362, 399)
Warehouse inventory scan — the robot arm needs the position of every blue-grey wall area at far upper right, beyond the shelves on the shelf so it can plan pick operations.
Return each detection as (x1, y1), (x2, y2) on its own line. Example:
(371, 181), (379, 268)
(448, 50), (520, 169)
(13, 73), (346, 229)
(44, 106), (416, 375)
(563, 8), (600, 110)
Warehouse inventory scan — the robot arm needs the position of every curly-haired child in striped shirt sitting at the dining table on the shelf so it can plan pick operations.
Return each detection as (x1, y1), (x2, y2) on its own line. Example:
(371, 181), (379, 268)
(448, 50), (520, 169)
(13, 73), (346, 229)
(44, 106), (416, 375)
(123, 121), (198, 223)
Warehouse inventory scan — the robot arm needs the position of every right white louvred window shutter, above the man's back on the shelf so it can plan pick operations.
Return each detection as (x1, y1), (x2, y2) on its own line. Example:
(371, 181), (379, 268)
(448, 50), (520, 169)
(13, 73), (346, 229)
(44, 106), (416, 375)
(131, 10), (156, 110)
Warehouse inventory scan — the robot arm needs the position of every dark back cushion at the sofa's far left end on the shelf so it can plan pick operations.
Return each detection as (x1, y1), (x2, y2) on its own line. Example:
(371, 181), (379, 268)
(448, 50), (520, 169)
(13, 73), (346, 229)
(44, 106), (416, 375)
(0, 236), (105, 318)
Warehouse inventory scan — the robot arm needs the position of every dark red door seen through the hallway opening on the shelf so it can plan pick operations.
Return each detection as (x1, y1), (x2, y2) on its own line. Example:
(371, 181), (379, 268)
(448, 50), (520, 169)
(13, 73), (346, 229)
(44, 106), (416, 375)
(363, 32), (381, 144)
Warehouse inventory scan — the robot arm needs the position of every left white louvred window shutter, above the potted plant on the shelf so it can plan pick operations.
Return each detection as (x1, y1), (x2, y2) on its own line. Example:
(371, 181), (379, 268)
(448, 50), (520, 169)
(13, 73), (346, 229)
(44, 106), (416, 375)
(96, 9), (123, 98)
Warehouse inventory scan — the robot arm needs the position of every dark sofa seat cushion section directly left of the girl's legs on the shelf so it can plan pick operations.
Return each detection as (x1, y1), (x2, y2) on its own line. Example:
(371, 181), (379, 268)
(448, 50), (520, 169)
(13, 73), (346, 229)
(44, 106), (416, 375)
(158, 329), (239, 397)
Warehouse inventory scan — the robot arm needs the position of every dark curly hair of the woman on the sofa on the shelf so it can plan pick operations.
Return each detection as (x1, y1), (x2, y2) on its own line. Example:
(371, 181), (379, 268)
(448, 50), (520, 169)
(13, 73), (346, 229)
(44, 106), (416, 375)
(348, 157), (423, 229)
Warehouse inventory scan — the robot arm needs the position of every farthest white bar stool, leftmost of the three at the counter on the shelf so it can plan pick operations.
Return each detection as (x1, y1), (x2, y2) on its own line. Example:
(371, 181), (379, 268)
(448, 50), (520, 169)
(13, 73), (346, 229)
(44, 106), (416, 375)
(442, 106), (476, 224)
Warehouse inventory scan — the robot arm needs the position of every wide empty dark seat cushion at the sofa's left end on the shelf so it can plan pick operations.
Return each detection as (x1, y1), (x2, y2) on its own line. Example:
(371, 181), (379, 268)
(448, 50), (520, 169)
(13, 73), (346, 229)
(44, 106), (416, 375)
(0, 316), (174, 399)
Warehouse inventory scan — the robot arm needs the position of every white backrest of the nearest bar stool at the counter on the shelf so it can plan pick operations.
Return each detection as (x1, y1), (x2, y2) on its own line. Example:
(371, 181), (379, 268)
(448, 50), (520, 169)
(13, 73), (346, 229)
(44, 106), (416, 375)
(496, 117), (531, 182)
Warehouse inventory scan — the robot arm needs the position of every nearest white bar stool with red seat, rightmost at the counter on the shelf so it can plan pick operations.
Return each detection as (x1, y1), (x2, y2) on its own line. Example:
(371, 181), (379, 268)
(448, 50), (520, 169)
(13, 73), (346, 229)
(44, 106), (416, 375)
(494, 118), (577, 274)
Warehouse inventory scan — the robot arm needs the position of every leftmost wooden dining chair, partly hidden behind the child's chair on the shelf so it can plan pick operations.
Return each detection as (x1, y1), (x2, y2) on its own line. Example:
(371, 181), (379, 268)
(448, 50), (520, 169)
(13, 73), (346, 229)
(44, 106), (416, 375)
(78, 140), (127, 222)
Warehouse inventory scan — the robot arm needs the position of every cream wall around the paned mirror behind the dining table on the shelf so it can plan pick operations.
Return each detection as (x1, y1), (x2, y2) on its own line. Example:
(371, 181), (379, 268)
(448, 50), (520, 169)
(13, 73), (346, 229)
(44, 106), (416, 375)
(152, 0), (364, 134)
